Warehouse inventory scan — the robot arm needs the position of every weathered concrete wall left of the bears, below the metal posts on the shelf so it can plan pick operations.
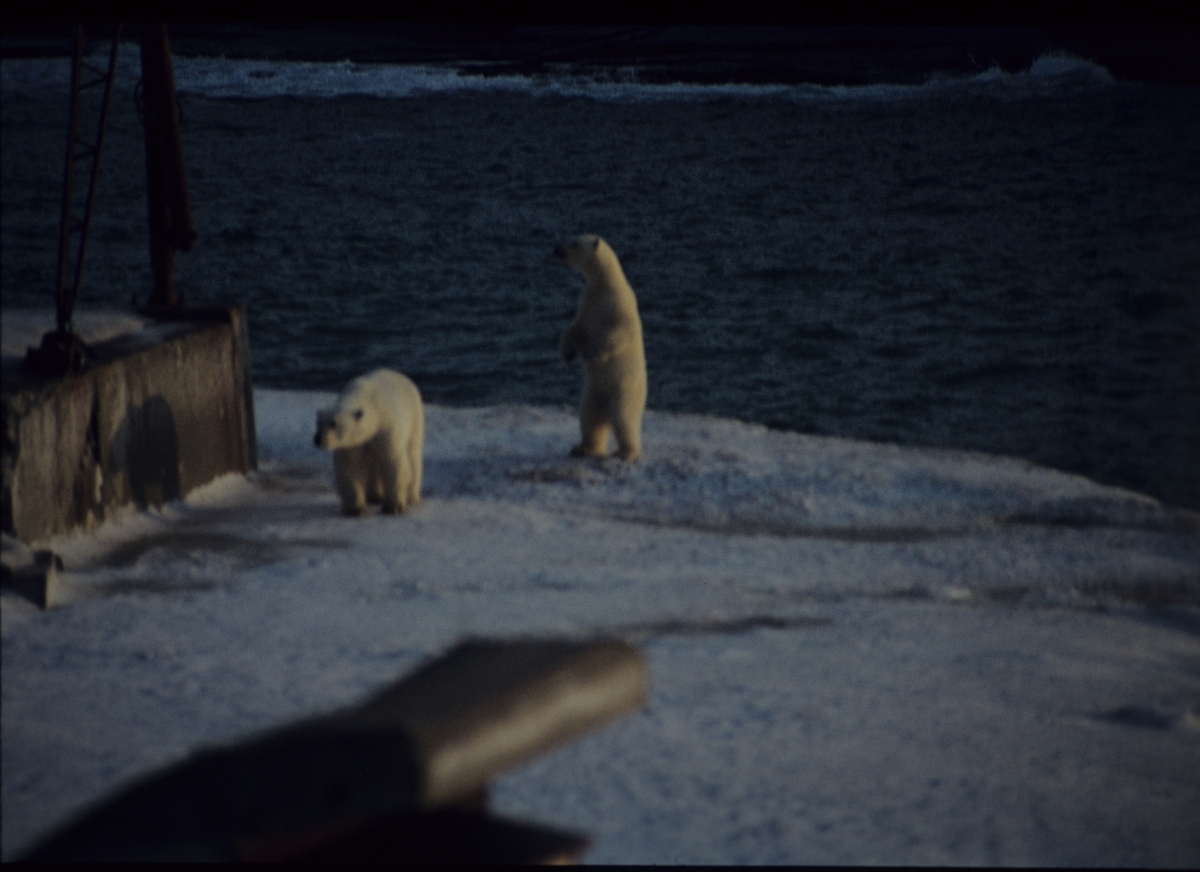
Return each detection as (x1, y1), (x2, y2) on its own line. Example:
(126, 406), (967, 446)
(0, 306), (258, 542)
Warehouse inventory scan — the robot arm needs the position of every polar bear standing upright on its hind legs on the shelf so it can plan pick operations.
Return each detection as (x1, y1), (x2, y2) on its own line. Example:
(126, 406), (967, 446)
(554, 234), (646, 461)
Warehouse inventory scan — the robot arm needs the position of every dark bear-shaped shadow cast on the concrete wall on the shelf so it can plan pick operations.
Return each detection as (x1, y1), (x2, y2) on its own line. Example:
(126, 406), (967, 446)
(113, 396), (182, 509)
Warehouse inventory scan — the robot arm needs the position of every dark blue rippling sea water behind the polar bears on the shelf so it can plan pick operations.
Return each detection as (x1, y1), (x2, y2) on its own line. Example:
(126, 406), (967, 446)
(7, 50), (1200, 507)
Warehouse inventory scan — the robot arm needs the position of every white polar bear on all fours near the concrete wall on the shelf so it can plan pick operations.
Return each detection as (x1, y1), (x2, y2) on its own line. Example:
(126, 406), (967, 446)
(313, 369), (425, 516)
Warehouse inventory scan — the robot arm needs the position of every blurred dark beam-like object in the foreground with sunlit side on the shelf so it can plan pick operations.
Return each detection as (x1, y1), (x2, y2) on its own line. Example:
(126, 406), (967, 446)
(25, 641), (647, 861)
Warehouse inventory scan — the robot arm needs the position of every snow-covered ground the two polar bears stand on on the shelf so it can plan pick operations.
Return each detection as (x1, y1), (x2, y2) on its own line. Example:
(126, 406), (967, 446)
(0, 390), (1200, 867)
